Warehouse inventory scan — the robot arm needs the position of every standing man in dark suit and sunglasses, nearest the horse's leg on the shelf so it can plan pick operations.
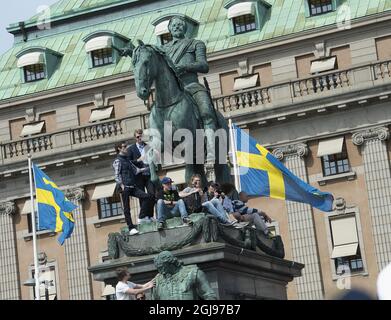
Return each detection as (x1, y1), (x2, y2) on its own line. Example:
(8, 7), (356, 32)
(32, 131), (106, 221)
(126, 129), (155, 222)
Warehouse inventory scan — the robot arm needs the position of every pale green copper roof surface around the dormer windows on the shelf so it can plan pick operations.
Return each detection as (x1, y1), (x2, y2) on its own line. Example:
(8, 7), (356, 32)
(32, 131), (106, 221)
(0, 0), (391, 101)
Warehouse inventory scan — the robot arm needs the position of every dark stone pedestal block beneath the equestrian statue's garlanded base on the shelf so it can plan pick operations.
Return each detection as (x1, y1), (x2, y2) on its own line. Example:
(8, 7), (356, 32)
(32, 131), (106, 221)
(89, 242), (304, 300)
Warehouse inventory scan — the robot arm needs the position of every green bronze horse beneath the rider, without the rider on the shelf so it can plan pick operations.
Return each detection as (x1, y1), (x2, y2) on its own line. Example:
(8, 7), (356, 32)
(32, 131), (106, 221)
(132, 41), (231, 183)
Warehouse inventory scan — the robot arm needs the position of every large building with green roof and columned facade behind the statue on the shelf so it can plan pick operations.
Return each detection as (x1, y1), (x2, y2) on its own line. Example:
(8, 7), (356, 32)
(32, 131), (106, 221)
(0, 0), (391, 300)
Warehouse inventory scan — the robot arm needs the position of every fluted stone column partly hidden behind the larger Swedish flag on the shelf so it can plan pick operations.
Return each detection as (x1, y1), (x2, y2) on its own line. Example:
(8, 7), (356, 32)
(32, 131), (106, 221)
(273, 143), (324, 300)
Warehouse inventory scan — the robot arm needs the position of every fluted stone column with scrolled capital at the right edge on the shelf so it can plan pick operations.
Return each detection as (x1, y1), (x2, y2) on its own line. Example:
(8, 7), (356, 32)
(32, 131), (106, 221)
(353, 127), (391, 271)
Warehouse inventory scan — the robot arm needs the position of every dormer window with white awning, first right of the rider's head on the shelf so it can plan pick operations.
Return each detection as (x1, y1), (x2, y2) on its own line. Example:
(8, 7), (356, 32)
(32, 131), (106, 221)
(224, 0), (271, 35)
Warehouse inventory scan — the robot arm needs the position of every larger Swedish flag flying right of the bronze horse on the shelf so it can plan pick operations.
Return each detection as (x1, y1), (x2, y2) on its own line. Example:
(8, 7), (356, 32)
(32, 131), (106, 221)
(233, 125), (334, 212)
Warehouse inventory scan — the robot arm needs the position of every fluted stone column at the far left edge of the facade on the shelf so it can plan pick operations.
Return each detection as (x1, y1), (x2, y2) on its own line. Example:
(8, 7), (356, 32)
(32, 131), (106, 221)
(0, 202), (20, 300)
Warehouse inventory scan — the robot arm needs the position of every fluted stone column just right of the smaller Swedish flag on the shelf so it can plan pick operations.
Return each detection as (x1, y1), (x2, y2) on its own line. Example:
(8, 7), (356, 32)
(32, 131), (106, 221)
(65, 188), (92, 300)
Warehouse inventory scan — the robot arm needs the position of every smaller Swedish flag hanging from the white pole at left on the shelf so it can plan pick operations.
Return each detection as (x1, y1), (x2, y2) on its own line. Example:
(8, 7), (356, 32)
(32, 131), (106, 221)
(33, 164), (77, 245)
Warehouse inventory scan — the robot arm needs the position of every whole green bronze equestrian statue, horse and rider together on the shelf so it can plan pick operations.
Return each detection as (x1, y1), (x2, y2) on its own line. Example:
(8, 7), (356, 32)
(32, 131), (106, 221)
(115, 16), (231, 183)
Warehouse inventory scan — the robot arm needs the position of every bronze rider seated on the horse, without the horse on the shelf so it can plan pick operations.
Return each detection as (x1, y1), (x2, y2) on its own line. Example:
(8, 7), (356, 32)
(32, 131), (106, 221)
(163, 16), (217, 162)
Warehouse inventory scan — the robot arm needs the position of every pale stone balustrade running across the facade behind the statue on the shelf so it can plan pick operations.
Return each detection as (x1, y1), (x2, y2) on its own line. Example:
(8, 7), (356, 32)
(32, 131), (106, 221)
(0, 60), (391, 164)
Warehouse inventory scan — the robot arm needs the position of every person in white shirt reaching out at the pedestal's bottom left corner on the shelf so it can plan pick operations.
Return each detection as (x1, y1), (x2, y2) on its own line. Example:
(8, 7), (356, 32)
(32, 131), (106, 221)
(115, 269), (155, 300)
